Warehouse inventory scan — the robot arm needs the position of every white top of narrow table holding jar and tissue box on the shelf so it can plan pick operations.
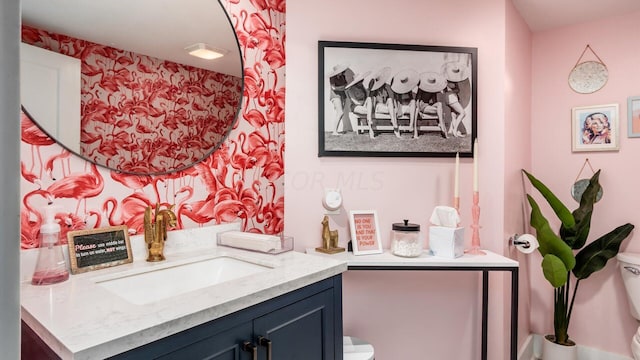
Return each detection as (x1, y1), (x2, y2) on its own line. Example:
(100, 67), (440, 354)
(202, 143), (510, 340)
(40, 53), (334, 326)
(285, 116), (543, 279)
(306, 248), (519, 270)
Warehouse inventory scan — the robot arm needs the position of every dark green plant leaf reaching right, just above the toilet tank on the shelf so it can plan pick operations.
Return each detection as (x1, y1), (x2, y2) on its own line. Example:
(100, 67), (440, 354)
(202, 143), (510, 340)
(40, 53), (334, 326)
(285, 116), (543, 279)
(573, 223), (634, 280)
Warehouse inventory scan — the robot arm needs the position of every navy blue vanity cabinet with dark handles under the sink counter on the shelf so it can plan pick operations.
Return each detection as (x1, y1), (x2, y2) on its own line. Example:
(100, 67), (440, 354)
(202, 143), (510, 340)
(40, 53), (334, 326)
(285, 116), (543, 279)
(113, 275), (342, 360)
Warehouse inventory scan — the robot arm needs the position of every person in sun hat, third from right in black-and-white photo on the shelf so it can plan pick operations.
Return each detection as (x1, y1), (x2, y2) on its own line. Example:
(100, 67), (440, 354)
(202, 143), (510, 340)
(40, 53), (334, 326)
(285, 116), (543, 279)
(391, 69), (419, 138)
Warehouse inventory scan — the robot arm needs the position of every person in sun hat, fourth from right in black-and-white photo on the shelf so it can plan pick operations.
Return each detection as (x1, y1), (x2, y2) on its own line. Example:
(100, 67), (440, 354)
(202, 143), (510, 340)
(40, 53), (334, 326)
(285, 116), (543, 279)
(367, 67), (393, 139)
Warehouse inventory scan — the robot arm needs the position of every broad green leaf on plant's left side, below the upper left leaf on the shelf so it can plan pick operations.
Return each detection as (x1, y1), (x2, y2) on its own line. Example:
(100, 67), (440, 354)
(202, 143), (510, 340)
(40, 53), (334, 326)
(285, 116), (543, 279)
(527, 194), (576, 271)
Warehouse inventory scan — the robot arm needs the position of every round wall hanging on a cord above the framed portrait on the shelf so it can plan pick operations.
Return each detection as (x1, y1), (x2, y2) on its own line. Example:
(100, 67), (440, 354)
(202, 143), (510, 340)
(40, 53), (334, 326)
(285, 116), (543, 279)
(569, 45), (609, 94)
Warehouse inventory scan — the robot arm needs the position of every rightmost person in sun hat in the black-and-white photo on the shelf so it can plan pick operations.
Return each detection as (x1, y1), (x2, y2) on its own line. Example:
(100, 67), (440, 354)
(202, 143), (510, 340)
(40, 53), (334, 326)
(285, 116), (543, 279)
(442, 61), (470, 137)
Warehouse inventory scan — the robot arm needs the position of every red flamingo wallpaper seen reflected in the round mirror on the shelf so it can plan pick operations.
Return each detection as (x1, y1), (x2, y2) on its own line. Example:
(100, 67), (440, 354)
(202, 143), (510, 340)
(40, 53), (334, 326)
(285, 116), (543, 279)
(22, 25), (242, 174)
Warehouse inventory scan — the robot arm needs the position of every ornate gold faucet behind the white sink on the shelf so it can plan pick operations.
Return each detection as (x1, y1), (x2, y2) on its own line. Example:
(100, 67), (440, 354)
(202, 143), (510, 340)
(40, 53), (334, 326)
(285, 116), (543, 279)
(144, 204), (177, 261)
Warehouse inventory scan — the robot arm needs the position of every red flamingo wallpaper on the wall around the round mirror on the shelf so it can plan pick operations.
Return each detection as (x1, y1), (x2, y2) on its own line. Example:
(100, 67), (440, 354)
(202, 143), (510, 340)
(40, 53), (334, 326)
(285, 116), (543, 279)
(20, 0), (285, 249)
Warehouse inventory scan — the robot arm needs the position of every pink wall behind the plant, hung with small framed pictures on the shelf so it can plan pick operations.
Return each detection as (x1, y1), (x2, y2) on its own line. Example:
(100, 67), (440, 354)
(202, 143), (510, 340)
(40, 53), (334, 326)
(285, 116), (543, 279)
(531, 9), (640, 356)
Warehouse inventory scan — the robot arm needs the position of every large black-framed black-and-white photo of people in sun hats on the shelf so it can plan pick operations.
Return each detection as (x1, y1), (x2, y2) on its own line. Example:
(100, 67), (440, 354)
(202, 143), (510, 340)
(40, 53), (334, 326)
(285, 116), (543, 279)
(318, 41), (477, 157)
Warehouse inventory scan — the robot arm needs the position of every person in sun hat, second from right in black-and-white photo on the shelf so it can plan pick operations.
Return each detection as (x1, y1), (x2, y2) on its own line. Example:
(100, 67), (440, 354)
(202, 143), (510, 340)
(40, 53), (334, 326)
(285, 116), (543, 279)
(413, 72), (448, 139)
